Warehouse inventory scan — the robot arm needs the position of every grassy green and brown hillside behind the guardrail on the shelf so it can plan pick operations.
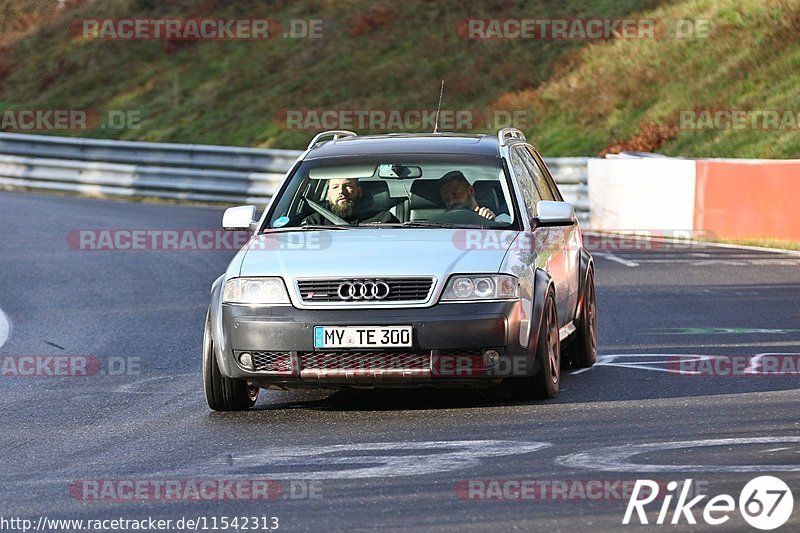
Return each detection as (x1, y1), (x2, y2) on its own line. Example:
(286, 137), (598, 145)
(0, 0), (800, 157)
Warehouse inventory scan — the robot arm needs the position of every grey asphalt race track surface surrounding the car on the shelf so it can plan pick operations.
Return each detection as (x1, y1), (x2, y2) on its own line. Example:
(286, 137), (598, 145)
(0, 192), (800, 531)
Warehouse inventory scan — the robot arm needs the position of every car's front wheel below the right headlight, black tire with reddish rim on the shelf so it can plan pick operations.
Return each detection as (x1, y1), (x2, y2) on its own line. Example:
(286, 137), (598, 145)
(513, 290), (561, 400)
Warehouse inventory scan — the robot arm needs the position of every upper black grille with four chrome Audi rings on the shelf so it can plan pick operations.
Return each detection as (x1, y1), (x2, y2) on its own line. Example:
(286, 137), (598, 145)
(297, 278), (433, 304)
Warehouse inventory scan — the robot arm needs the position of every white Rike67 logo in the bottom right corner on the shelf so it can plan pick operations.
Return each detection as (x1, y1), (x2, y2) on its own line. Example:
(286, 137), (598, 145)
(622, 476), (794, 531)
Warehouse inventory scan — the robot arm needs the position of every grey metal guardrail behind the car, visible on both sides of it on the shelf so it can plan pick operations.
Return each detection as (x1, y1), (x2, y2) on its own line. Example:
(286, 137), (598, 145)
(0, 133), (589, 226)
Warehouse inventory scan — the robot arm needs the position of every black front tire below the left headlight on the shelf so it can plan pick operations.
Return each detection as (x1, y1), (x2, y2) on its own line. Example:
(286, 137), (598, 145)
(203, 314), (258, 411)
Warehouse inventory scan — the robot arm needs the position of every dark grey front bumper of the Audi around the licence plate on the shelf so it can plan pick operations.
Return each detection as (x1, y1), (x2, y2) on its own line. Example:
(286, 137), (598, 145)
(215, 300), (535, 388)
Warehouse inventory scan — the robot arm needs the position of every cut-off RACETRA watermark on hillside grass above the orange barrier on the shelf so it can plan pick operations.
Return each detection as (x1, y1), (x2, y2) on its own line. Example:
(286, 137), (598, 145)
(678, 109), (800, 131)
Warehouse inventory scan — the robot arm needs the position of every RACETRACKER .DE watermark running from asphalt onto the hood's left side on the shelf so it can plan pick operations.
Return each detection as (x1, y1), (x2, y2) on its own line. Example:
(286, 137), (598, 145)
(66, 229), (332, 252)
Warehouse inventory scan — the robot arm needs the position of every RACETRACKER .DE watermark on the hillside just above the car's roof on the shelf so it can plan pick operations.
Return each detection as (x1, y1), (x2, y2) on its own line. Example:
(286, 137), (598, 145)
(273, 108), (533, 131)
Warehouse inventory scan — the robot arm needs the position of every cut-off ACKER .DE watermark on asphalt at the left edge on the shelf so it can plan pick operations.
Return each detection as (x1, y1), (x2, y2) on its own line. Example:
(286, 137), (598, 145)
(0, 355), (142, 378)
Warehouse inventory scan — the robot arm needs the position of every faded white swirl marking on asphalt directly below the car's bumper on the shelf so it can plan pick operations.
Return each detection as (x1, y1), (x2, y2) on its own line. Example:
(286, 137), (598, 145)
(148, 440), (552, 480)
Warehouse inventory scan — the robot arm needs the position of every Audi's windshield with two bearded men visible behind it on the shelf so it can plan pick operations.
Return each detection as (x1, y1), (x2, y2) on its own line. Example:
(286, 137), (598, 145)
(263, 154), (518, 230)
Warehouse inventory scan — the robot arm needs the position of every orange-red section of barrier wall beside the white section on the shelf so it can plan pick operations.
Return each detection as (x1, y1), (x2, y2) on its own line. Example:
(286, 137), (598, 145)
(694, 161), (800, 241)
